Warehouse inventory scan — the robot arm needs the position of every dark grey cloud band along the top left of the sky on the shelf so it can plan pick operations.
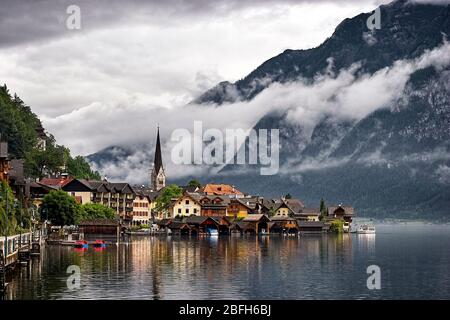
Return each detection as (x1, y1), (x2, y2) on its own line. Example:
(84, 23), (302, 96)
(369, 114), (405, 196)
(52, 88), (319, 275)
(0, 0), (386, 47)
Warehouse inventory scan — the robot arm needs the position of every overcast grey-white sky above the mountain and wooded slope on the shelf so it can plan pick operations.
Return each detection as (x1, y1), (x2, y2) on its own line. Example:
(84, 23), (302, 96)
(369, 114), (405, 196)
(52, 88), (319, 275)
(0, 0), (398, 155)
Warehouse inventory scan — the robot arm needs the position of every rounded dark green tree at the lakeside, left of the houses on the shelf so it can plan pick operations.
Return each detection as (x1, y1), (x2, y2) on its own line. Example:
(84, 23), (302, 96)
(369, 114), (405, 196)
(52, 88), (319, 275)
(41, 190), (80, 226)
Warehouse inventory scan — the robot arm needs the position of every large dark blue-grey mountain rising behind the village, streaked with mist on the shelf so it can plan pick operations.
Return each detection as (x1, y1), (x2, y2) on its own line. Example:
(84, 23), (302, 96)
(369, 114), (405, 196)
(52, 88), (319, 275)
(88, 1), (450, 219)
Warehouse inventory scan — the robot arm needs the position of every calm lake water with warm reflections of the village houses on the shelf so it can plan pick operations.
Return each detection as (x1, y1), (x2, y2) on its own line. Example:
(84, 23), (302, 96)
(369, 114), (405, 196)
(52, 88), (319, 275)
(6, 223), (450, 299)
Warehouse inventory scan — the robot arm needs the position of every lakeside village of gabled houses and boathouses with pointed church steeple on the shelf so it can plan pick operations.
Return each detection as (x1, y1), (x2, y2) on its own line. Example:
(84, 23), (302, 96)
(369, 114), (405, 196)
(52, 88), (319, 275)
(0, 129), (354, 245)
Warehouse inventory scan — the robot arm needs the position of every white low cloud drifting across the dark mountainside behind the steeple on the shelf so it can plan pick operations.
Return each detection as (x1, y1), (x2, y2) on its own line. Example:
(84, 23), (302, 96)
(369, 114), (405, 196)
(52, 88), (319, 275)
(87, 41), (450, 182)
